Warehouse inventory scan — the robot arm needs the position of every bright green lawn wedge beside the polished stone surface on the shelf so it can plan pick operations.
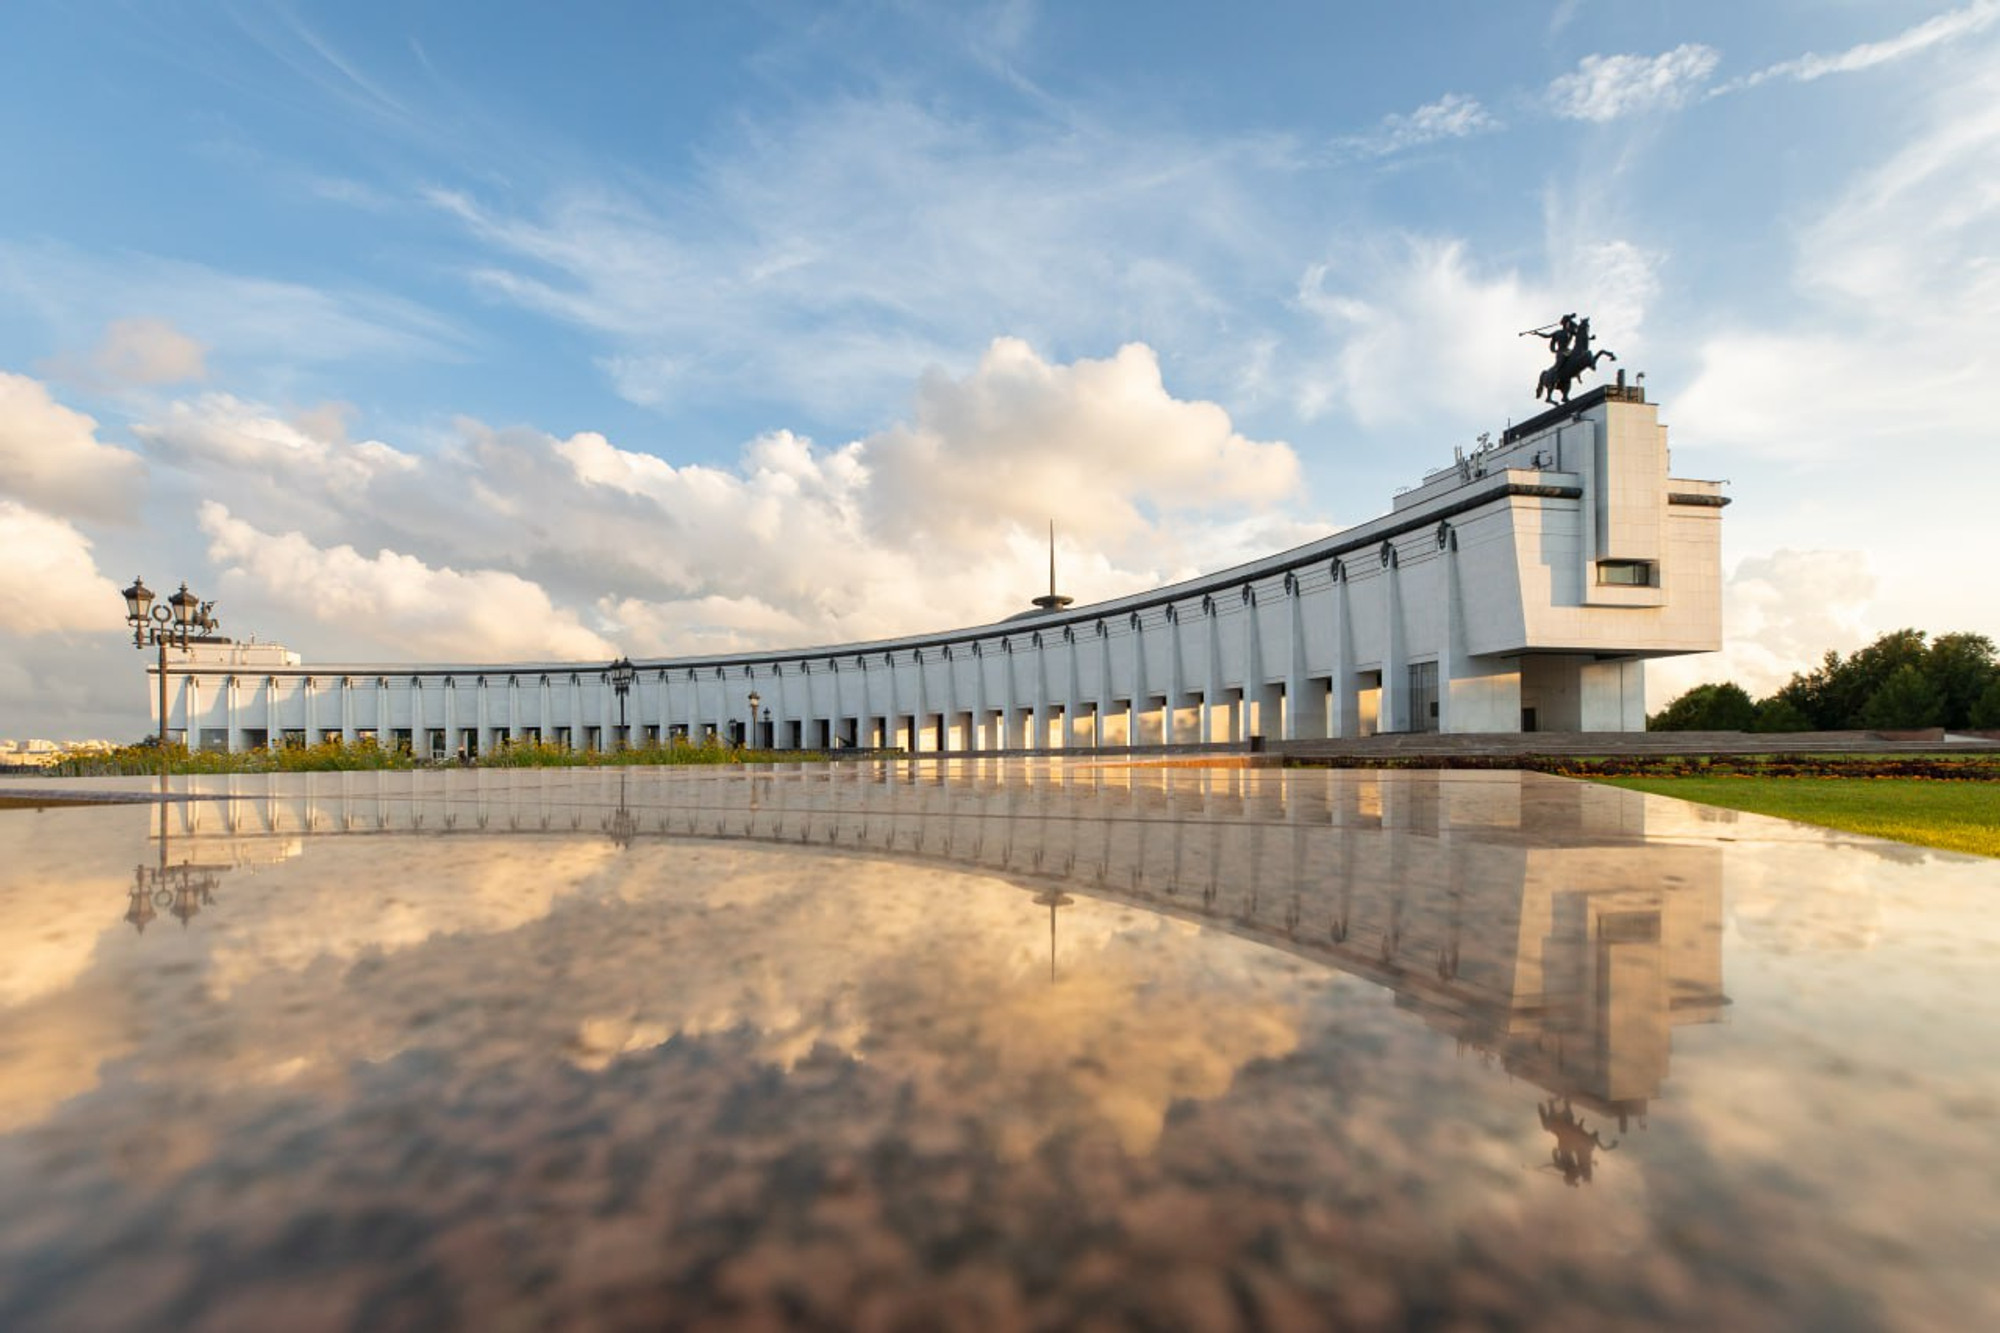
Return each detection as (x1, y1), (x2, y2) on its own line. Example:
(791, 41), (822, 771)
(1598, 777), (2000, 857)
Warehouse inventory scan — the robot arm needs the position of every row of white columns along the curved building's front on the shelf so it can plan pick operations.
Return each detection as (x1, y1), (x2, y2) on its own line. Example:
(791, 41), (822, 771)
(170, 524), (1470, 751)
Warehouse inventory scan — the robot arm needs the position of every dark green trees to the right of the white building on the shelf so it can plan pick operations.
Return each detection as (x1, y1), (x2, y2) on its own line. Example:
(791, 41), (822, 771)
(1646, 628), (2000, 731)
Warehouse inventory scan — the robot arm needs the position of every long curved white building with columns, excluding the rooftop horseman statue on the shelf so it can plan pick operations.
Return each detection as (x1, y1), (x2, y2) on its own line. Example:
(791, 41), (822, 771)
(156, 384), (1728, 755)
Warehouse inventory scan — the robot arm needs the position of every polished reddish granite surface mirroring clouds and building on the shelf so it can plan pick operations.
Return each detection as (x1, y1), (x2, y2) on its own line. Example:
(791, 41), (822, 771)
(0, 763), (2000, 1331)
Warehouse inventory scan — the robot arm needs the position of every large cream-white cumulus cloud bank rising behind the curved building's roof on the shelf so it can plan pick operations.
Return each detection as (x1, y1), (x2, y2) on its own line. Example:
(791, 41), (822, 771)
(140, 338), (1324, 660)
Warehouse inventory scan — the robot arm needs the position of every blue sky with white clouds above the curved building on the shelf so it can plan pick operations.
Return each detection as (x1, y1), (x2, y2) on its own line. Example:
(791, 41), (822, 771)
(0, 0), (2000, 741)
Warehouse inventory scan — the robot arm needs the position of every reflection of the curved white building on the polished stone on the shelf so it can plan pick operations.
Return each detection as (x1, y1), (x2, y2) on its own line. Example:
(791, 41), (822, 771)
(148, 761), (1728, 1185)
